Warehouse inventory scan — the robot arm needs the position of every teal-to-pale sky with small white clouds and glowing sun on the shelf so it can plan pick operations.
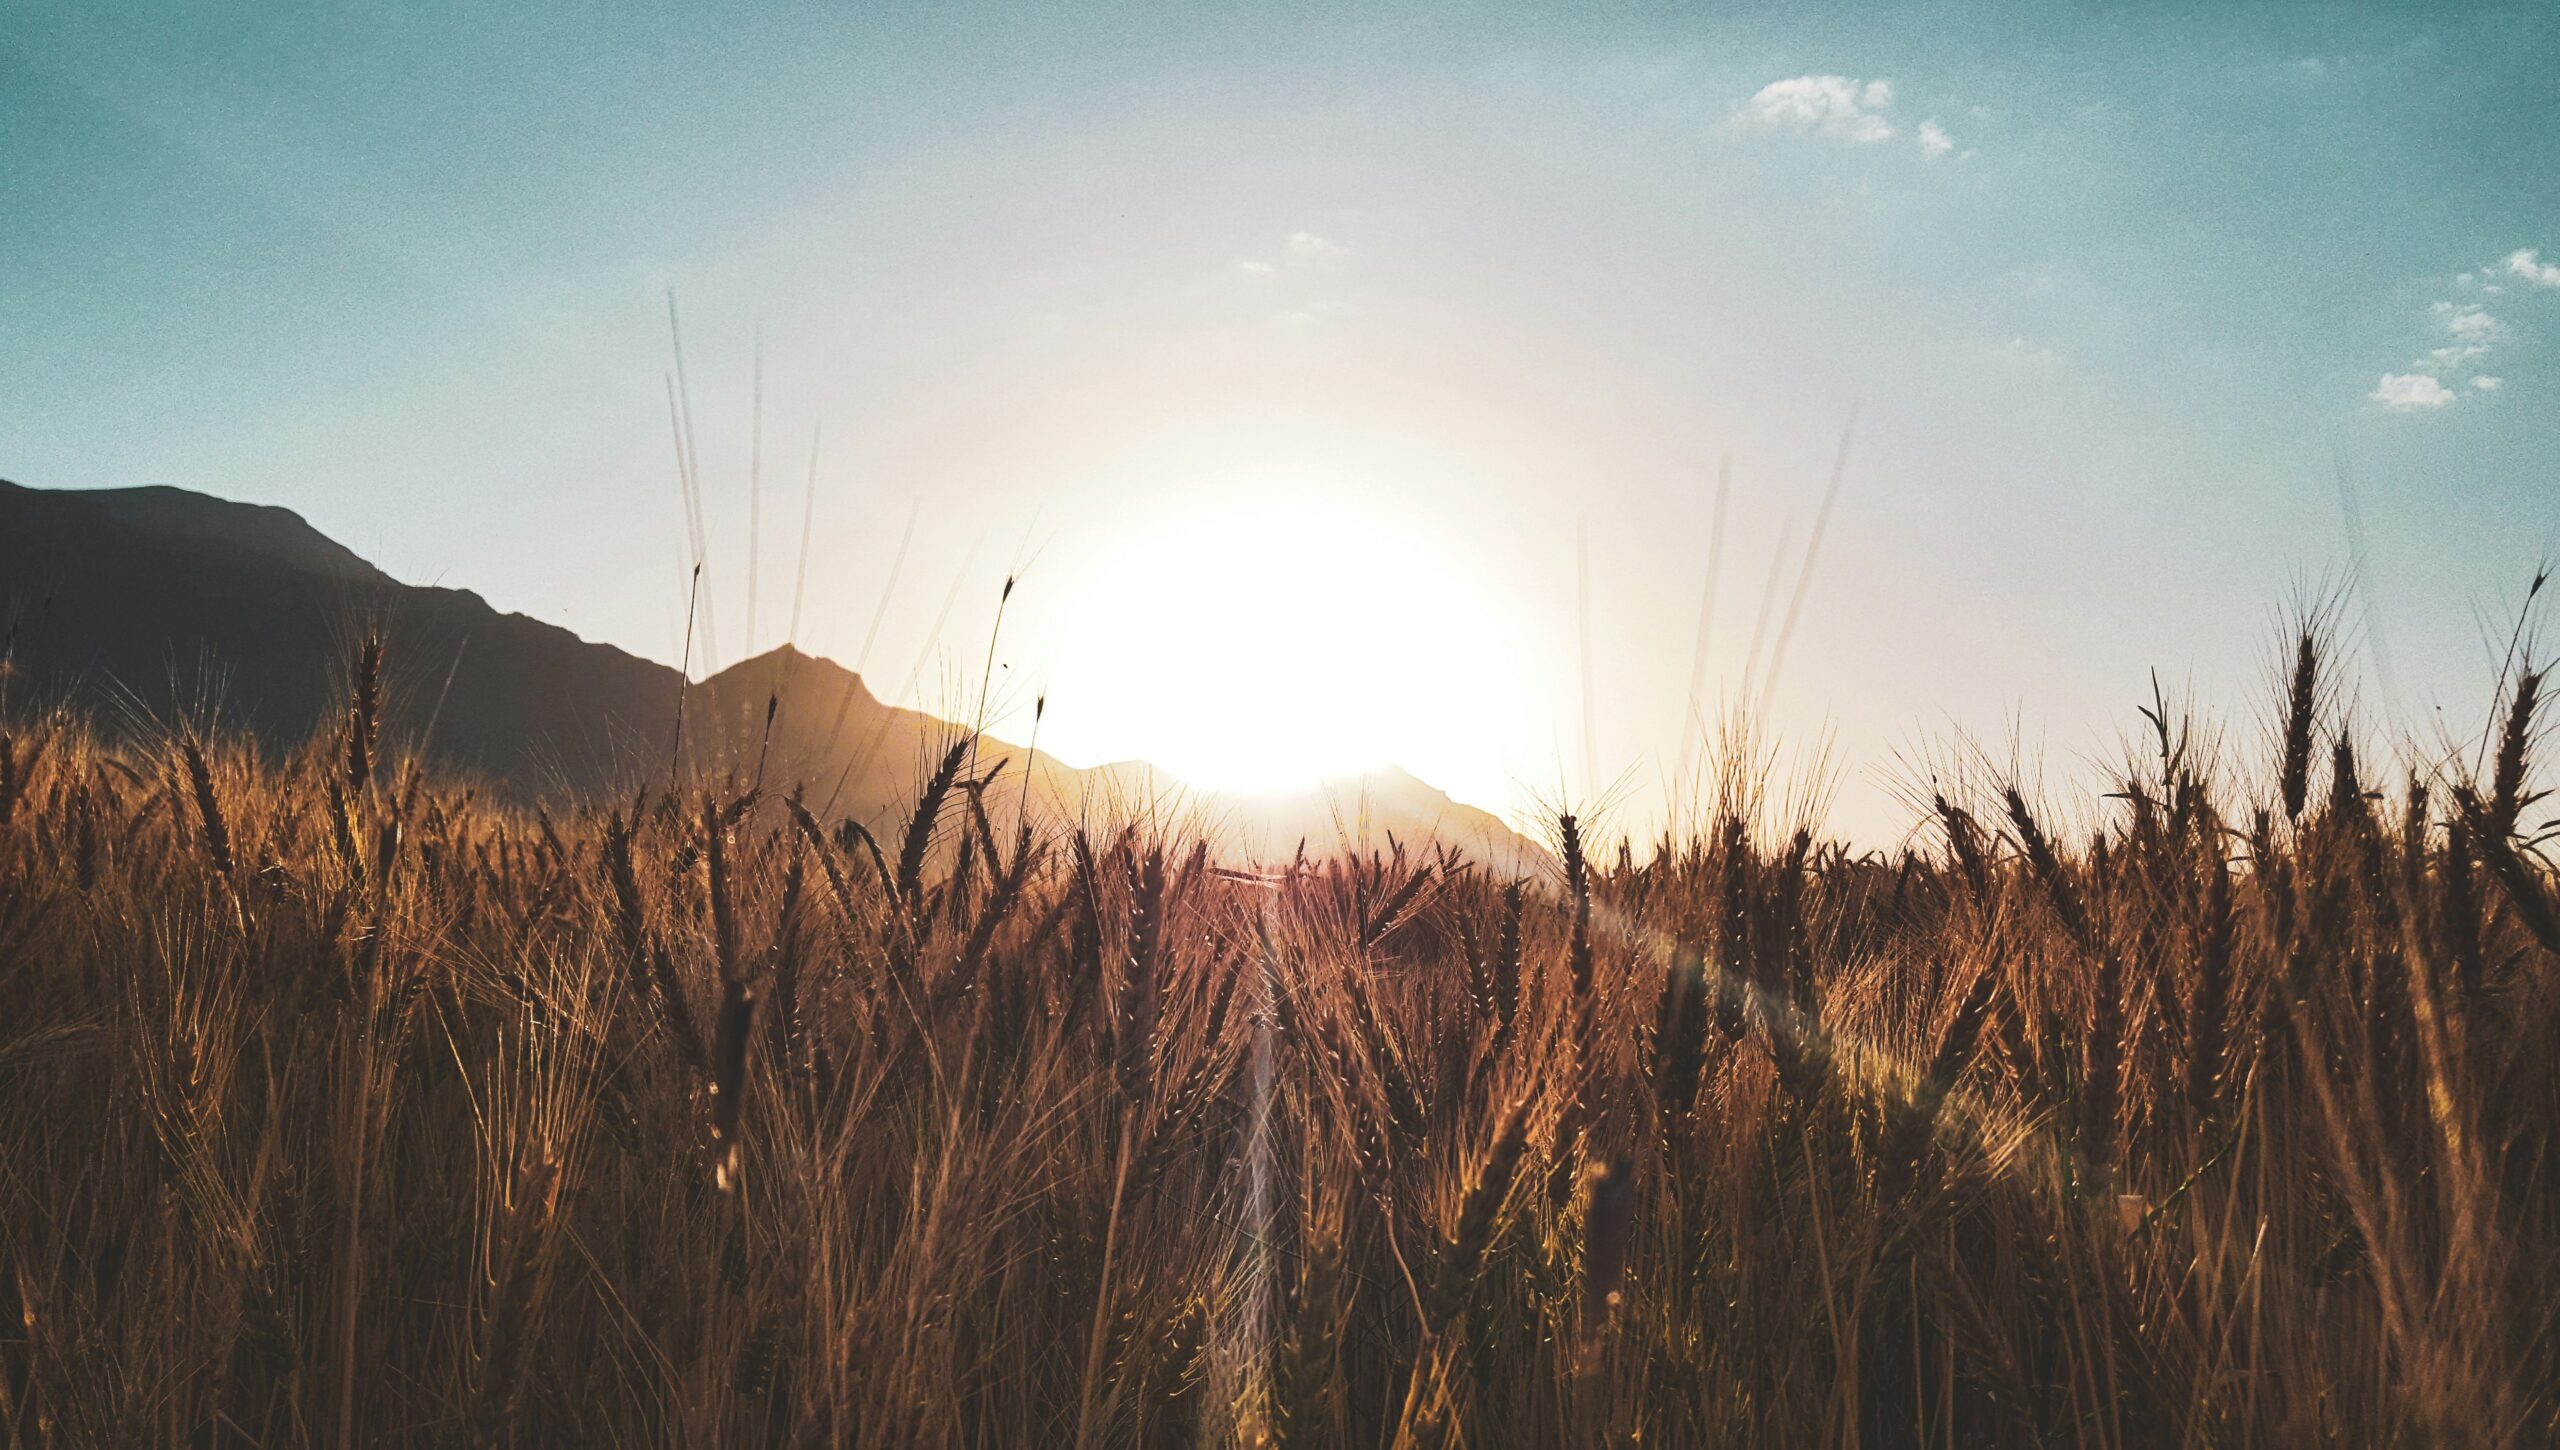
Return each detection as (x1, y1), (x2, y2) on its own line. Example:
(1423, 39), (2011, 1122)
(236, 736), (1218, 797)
(0, 0), (2560, 840)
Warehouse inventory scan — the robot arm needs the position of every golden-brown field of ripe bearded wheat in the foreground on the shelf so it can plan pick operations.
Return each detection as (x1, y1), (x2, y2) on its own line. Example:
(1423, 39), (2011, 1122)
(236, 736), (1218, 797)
(0, 617), (2560, 1447)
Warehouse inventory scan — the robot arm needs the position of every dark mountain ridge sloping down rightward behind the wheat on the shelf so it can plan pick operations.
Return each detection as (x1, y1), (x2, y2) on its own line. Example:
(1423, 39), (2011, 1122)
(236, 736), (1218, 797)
(0, 482), (1544, 868)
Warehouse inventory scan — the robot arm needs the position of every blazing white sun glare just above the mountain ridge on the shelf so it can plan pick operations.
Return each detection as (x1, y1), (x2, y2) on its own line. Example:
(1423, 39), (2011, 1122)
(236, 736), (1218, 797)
(1047, 484), (1526, 810)
